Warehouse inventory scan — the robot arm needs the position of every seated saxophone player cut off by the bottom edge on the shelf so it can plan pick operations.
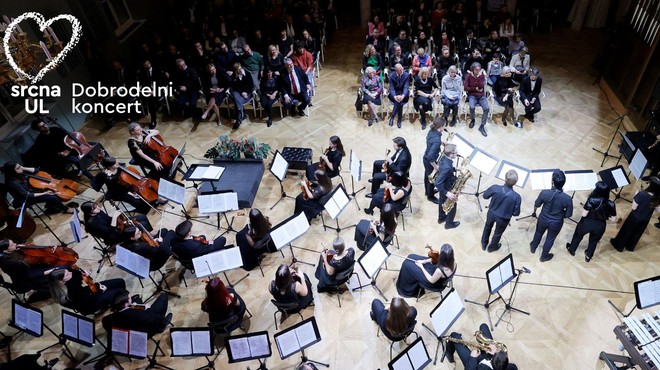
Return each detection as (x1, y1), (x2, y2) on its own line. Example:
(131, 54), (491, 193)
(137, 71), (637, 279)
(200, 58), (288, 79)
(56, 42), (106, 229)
(445, 323), (518, 370)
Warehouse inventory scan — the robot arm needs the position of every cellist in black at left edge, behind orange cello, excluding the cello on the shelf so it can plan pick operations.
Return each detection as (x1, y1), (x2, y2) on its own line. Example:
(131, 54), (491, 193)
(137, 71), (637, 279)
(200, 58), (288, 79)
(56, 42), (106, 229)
(2, 162), (78, 214)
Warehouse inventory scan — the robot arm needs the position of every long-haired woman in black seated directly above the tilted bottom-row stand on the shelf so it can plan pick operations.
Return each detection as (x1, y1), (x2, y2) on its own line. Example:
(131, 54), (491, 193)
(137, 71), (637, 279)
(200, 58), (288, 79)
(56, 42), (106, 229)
(268, 264), (314, 314)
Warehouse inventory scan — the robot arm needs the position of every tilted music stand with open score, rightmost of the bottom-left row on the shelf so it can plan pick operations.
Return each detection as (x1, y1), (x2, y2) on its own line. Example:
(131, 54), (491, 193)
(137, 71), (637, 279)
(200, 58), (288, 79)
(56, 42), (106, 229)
(273, 316), (330, 367)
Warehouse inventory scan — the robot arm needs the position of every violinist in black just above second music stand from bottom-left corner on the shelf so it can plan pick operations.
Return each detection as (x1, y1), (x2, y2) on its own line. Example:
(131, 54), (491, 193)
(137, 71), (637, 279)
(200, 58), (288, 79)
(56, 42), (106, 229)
(47, 266), (126, 315)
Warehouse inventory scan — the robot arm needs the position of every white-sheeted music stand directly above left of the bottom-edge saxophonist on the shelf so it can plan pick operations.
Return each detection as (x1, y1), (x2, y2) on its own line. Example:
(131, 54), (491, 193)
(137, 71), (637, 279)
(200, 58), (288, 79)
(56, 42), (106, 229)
(422, 288), (465, 365)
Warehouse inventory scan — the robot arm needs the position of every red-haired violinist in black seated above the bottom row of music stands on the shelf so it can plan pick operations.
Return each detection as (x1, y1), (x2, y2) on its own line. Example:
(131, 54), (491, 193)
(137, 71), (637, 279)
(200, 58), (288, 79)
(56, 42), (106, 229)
(202, 277), (247, 332)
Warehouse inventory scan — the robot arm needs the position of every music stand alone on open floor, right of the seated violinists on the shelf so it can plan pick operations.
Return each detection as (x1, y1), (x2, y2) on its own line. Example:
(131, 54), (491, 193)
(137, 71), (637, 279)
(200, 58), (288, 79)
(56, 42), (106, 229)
(465, 253), (530, 330)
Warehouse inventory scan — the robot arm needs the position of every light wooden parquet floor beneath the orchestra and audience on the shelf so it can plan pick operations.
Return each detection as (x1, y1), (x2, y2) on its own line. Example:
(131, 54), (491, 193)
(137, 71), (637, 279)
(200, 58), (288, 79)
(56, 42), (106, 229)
(0, 23), (660, 369)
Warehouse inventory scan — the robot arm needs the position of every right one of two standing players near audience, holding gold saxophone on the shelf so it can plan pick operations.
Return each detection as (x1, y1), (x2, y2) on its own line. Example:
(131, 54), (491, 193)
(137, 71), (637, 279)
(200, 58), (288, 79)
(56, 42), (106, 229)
(435, 144), (461, 229)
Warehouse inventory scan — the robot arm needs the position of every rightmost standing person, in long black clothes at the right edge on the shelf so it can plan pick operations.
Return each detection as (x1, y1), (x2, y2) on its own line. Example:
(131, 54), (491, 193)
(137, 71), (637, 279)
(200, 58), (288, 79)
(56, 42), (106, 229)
(610, 176), (660, 252)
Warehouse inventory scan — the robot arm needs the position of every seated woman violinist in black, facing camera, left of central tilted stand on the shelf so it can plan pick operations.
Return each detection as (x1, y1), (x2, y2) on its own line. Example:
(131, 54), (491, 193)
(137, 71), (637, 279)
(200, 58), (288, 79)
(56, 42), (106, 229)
(314, 237), (355, 293)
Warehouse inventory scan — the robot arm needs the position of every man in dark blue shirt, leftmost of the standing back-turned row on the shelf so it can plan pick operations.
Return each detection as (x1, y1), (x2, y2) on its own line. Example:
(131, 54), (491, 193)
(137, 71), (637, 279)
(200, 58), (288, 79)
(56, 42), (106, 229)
(481, 170), (521, 252)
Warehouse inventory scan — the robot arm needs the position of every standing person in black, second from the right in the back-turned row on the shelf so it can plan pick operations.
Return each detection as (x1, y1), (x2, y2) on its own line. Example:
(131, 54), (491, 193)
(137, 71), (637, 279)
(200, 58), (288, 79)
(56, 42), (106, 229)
(566, 181), (617, 262)
